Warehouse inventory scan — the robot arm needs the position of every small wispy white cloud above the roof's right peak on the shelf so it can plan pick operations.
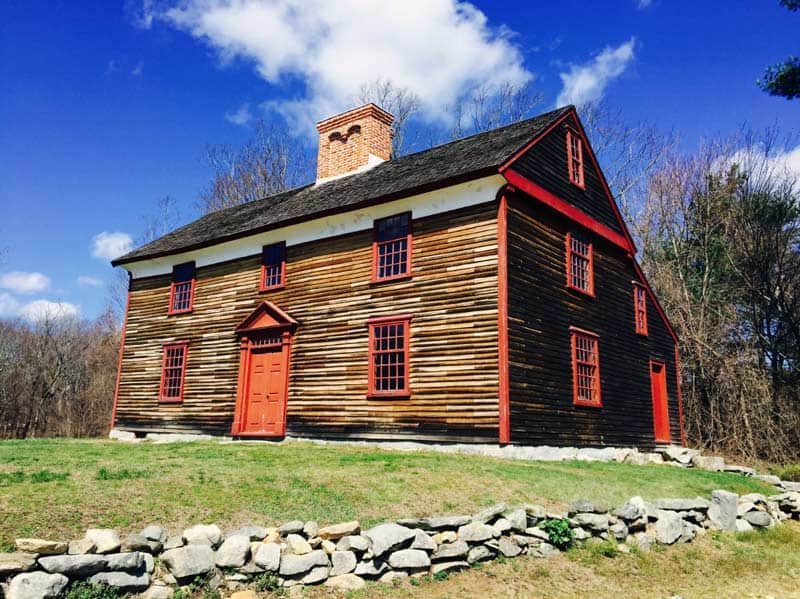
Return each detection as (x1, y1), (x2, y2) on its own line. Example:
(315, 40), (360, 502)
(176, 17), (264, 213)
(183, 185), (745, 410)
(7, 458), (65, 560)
(556, 38), (636, 106)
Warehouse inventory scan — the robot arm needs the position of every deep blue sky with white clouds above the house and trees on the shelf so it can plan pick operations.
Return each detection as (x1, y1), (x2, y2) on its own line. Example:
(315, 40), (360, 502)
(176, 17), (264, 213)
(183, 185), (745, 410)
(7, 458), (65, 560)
(0, 0), (800, 318)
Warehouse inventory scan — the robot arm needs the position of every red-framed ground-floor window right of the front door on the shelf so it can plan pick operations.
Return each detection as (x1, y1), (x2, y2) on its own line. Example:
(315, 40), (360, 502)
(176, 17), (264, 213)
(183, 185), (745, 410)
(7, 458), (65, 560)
(367, 314), (411, 398)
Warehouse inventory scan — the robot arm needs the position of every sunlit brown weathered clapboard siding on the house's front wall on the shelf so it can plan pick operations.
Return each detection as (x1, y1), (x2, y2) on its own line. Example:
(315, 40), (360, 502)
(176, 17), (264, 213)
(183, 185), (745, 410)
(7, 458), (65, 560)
(116, 198), (498, 440)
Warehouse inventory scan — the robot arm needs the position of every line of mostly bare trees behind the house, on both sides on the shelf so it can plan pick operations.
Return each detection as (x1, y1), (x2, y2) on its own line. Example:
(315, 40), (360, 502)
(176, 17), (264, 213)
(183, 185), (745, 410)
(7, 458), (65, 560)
(0, 81), (800, 461)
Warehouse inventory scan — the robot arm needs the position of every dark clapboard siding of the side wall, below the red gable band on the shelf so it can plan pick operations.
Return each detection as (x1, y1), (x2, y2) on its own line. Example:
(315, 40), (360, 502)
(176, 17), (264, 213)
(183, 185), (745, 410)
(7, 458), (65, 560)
(508, 194), (680, 446)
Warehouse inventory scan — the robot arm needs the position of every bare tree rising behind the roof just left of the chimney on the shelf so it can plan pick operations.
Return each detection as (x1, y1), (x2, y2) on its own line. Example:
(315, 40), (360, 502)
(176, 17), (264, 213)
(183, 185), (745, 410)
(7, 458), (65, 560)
(198, 120), (313, 214)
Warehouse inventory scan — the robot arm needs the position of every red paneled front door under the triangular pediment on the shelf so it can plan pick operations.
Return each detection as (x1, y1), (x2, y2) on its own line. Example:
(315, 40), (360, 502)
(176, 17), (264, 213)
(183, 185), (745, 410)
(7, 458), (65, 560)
(240, 345), (287, 436)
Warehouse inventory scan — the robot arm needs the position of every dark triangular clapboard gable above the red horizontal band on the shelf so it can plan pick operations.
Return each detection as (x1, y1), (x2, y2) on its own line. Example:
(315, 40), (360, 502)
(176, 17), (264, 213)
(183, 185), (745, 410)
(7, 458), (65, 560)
(514, 115), (622, 233)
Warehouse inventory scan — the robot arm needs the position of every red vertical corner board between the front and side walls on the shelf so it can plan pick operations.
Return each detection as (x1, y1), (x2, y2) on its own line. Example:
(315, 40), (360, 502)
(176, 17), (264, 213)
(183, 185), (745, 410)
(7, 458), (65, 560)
(497, 192), (511, 443)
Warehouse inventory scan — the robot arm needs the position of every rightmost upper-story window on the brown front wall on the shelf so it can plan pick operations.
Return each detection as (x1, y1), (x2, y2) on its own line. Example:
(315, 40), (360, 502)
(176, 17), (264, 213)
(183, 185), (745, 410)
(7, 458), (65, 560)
(372, 212), (411, 282)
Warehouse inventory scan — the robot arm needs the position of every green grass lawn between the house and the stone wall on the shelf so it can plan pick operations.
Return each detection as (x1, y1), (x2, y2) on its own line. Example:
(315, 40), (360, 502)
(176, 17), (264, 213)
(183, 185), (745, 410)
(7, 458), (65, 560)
(0, 439), (775, 544)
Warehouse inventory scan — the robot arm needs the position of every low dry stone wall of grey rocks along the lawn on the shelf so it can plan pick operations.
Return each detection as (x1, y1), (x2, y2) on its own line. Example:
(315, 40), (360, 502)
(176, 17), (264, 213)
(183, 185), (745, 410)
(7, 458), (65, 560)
(0, 448), (800, 599)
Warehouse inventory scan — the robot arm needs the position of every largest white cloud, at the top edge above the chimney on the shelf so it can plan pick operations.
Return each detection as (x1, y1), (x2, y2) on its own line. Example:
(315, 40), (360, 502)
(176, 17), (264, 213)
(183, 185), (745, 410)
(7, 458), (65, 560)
(145, 0), (533, 126)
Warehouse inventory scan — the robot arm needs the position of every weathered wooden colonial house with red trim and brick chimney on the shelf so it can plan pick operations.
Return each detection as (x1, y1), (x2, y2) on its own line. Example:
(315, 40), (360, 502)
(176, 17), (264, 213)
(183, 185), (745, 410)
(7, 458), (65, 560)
(113, 104), (682, 446)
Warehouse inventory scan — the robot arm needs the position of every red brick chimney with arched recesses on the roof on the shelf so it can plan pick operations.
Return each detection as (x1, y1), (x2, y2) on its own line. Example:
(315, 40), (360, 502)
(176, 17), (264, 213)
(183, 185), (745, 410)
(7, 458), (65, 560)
(317, 104), (394, 183)
